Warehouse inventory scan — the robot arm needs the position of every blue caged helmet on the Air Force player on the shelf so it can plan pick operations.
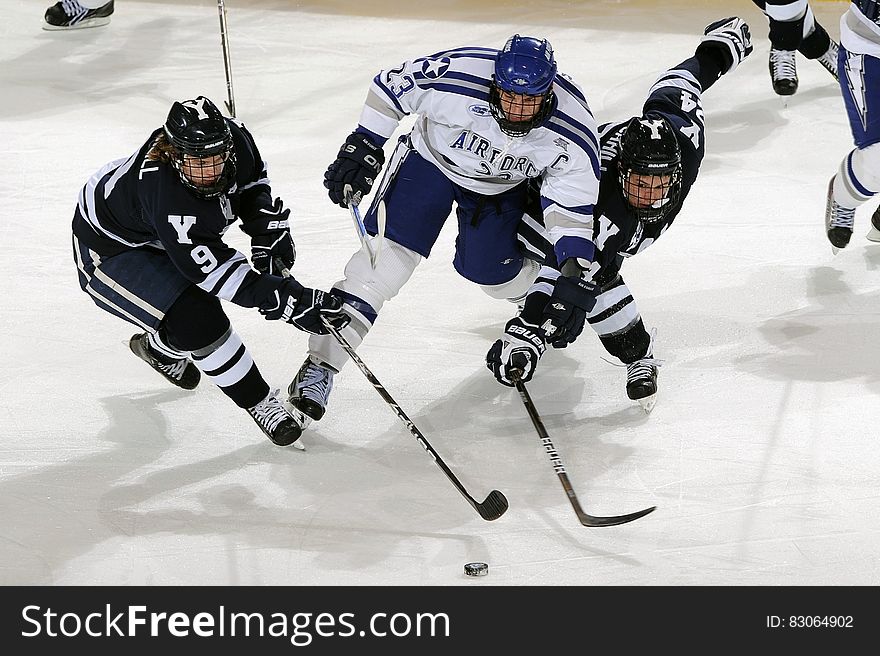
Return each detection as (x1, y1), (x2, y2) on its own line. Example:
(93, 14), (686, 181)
(489, 34), (556, 137)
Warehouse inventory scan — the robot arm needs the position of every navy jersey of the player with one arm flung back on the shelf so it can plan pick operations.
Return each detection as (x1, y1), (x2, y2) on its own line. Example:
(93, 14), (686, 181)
(590, 58), (705, 284)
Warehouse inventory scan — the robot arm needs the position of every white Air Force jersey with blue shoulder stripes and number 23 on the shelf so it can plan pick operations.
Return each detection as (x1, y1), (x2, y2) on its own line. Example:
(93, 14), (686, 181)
(360, 47), (599, 258)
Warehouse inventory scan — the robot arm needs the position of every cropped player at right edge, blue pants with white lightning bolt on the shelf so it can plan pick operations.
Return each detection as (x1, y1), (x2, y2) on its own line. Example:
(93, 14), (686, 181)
(825, 0), (880, 253)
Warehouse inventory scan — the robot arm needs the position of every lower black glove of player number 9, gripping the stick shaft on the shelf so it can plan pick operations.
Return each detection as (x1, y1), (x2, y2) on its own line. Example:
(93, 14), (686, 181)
(259, 278), (351, 335)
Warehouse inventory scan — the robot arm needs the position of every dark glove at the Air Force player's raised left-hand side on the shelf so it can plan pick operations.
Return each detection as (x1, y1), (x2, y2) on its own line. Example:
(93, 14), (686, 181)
(324, 132), (385, 207)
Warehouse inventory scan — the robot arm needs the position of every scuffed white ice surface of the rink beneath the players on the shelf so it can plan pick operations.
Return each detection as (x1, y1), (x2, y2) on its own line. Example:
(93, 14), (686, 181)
(0, 0), (880, 586)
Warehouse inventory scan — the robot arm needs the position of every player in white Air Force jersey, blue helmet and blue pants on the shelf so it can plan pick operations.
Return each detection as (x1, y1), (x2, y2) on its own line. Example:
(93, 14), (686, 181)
(288, 34), (599, 420)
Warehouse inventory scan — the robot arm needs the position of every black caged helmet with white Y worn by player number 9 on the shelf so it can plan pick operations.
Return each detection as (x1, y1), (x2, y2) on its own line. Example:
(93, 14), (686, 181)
(164, 96), (235, 198)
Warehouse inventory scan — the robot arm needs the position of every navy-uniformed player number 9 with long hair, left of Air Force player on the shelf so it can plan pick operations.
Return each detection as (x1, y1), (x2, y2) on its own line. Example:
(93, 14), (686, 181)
(73, 96), (348, 447)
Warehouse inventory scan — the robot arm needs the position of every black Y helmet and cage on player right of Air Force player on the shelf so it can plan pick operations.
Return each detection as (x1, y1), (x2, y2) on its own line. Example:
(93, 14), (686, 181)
(618, 116), (682, 223)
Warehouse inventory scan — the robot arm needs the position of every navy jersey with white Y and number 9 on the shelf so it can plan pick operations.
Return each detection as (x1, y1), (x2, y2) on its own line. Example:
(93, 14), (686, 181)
(73, 119), (282, 307)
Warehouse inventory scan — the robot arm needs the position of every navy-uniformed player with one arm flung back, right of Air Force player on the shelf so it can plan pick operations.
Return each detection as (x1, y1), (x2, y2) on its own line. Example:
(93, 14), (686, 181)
(486, 18), (752, 411)
